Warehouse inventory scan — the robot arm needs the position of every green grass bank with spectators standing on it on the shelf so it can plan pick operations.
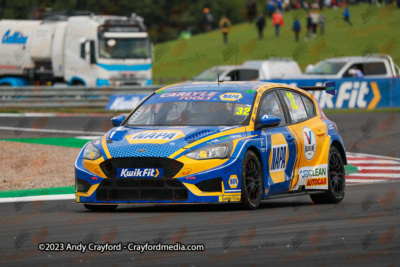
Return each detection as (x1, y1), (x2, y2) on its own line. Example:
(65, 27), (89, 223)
(153, 4), (400, 83)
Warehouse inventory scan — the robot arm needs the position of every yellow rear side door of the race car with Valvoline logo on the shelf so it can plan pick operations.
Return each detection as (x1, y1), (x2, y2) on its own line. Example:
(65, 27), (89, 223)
(280, 89), (330, 190)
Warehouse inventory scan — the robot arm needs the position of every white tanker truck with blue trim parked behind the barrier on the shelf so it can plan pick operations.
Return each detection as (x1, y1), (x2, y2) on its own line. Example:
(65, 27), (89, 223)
(0, 13), (153, 86)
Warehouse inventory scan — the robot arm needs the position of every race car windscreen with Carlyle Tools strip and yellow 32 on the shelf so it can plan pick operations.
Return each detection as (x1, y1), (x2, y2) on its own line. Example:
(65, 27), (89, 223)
(125, 91), (255, 126)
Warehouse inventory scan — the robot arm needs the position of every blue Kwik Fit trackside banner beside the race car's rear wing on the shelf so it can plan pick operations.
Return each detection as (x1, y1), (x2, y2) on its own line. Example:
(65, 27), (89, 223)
(270, 78), (400, 109)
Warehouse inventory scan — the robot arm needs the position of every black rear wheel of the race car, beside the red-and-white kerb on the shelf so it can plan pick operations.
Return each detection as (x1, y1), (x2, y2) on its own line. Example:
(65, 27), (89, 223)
(310, 146), (346, 204)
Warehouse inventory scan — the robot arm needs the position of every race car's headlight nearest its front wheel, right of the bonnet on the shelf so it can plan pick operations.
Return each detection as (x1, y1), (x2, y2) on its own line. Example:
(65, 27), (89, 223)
(186, 142), (233, 159)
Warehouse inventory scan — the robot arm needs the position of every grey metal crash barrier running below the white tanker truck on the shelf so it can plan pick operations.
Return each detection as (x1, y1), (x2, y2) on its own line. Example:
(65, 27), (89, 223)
(0, 85), (163, 108)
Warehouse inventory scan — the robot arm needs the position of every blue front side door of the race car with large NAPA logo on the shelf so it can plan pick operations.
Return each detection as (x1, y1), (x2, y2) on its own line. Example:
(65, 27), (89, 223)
(256, 90), (296, 196)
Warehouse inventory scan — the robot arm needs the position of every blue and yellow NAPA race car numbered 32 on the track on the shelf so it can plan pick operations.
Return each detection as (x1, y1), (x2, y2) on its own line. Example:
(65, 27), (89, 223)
(75, 82), (347, 211)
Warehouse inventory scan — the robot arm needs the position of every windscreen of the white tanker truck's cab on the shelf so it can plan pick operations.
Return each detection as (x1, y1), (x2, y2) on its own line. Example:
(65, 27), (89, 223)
(99, 37), (150, 59)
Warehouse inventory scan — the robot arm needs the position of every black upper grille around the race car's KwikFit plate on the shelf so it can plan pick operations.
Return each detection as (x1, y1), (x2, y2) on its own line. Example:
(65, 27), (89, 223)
(100, 157), (183, 178)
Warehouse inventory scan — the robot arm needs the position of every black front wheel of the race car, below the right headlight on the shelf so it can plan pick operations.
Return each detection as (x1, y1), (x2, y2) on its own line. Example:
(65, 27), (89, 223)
(241, 150), (264, 210)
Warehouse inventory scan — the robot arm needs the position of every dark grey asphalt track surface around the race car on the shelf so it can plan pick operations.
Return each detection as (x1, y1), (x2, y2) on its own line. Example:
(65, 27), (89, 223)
(0, 113), (400, 266)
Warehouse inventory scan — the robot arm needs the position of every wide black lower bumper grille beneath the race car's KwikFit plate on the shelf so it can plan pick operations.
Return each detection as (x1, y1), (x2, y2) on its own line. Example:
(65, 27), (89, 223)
(96, 178), (188, 201)
